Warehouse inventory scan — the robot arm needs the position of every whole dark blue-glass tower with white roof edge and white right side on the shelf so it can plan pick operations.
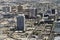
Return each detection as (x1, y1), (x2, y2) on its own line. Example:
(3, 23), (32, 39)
(17, 14), (25, 31)
